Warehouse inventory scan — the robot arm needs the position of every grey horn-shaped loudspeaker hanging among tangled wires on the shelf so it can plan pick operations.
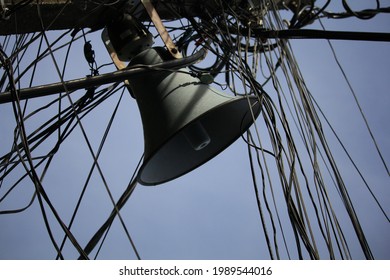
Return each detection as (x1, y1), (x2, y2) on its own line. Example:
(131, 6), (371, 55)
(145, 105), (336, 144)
(128, 48), (260, 185)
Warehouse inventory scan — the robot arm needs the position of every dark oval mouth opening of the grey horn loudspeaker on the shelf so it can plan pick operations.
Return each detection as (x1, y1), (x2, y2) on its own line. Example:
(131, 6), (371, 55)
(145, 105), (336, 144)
(137, 96), (260, 186)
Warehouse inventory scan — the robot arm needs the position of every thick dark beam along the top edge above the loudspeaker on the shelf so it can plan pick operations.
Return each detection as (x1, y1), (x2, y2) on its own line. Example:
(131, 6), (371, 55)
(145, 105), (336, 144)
(0, 0), (304, 35)
